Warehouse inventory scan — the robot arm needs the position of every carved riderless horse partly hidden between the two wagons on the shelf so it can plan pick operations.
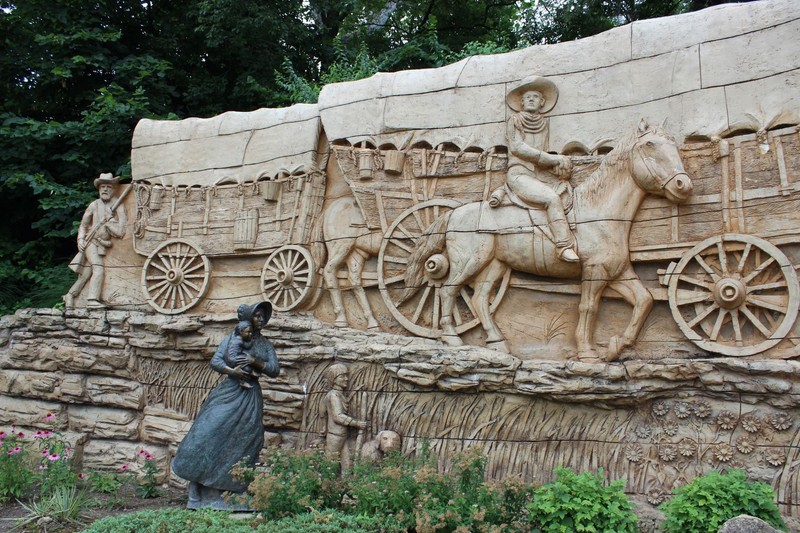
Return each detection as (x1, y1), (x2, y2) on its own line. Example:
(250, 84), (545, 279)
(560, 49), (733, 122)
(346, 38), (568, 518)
(320, 197), (381, 329)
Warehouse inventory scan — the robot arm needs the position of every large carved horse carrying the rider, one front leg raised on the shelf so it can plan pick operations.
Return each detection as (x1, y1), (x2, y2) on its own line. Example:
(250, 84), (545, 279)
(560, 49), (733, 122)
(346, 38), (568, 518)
(405, 120), (692, 361)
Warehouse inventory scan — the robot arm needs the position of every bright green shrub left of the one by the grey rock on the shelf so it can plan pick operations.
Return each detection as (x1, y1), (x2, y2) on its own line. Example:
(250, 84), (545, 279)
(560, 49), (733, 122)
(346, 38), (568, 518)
(528, 468), (638, 533)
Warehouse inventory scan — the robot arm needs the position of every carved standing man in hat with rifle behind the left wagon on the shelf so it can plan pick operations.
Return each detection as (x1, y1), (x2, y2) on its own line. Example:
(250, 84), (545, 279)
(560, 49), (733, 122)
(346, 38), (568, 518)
(64, 173), (130, 309)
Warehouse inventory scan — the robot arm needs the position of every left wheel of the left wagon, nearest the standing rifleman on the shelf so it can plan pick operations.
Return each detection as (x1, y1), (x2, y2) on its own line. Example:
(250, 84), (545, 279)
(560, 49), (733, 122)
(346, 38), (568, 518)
(142, 239), (211, 315)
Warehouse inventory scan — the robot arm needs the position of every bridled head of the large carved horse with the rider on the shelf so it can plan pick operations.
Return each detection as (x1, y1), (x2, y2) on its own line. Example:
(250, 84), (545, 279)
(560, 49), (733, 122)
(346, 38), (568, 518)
(630, 119), (692, 204)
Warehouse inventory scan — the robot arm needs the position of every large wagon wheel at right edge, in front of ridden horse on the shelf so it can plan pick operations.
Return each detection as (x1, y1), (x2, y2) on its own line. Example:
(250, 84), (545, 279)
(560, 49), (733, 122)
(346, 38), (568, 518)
(669, 233), (800, 356)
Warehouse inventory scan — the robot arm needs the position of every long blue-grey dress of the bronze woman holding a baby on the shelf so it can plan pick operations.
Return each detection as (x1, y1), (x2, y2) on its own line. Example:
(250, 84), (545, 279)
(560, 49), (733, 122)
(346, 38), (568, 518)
(172, 306), (280, 492)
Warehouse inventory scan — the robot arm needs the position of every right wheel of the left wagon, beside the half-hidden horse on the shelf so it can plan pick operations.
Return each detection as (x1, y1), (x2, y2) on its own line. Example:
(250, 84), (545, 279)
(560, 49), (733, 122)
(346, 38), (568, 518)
(261, 245), (317, 311)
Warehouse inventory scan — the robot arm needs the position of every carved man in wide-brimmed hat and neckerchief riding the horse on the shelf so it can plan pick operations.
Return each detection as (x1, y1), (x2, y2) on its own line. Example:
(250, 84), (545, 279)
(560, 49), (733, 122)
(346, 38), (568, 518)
(506, 76), (579, 263)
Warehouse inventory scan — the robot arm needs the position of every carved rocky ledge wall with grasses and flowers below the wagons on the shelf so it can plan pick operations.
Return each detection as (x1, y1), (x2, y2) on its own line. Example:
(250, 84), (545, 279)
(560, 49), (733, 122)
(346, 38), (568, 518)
(0, 309), (800, 516)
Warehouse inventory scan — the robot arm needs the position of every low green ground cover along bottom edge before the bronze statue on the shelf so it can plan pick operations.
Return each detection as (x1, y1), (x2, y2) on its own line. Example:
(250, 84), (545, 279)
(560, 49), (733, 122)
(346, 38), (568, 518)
(84, 509), (405, 533)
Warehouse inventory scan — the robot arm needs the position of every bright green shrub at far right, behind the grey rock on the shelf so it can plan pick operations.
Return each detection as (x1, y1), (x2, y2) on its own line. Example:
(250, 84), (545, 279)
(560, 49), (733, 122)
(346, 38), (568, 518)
(660, 470), (786, 533)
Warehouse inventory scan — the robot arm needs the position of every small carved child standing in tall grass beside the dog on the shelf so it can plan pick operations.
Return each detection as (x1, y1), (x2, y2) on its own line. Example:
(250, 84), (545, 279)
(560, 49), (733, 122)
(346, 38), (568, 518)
(320, 363), (369, 471)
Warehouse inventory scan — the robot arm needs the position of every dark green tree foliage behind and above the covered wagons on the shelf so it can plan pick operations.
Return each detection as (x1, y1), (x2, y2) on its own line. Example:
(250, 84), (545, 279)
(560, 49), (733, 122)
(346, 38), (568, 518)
(0, 0), (744, 313)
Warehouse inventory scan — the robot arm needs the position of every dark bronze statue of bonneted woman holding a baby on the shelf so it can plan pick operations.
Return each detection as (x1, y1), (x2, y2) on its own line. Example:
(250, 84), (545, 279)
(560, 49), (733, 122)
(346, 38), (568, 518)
(172, 302), (280, 509)
